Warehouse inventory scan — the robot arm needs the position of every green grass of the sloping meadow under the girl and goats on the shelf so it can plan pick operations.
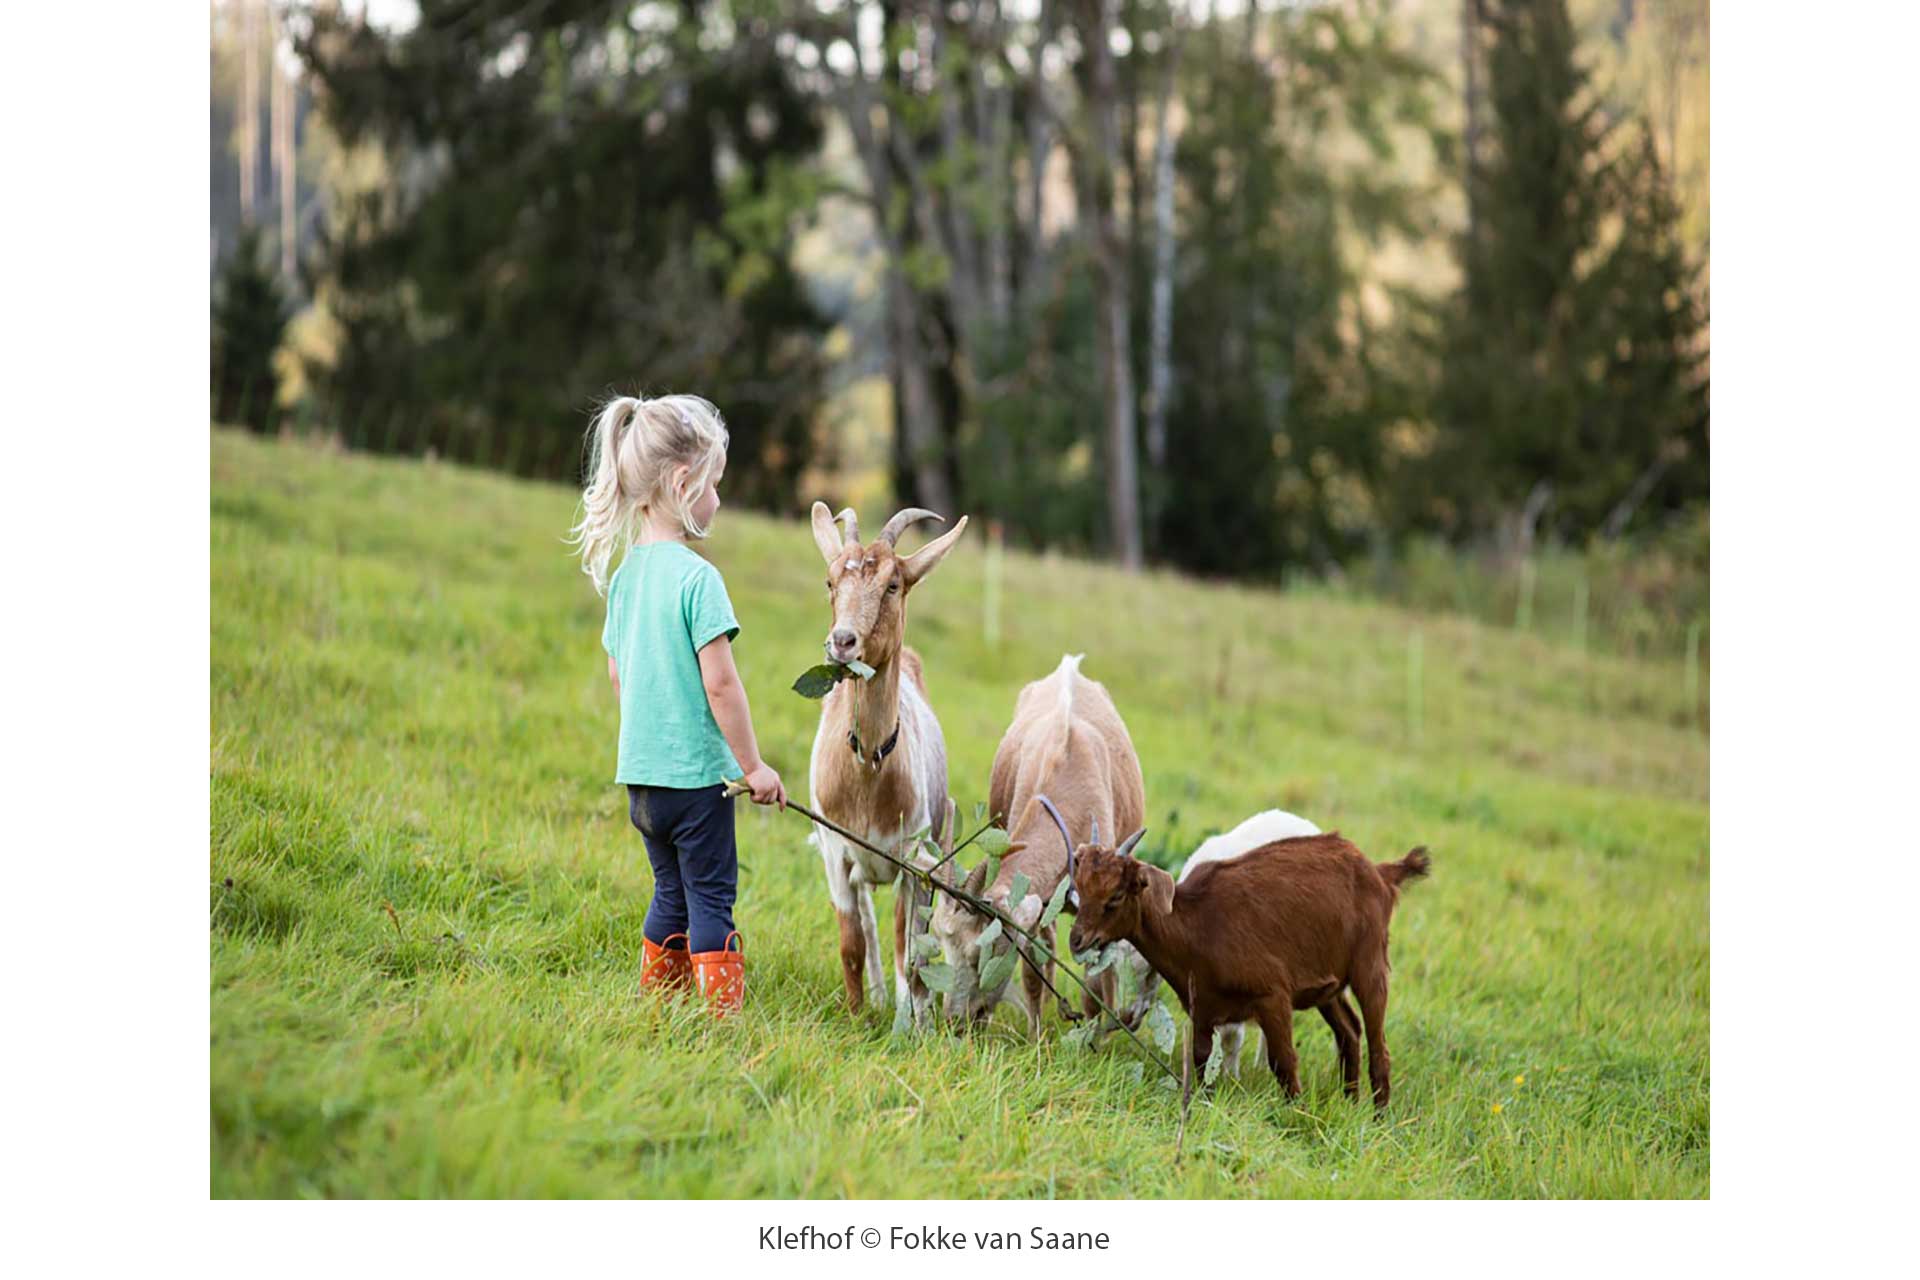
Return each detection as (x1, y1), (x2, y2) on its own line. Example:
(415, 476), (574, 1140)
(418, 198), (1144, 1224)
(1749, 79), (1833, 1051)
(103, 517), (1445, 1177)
(209, 432), (1709, 1197)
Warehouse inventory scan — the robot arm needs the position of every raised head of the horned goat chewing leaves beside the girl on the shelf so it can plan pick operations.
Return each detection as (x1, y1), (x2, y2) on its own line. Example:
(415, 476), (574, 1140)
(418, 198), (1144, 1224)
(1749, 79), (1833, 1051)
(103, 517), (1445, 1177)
(814, 503), (966, 668)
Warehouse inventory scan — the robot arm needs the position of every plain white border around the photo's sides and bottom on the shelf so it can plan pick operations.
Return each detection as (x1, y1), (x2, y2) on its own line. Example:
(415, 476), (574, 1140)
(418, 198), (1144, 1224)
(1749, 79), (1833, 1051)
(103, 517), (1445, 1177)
(15, 4), (1920, 1274)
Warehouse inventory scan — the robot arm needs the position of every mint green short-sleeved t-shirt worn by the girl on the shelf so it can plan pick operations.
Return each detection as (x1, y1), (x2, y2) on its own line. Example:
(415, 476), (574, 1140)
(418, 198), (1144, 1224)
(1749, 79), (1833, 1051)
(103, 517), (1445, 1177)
(601, 543), (743, 787)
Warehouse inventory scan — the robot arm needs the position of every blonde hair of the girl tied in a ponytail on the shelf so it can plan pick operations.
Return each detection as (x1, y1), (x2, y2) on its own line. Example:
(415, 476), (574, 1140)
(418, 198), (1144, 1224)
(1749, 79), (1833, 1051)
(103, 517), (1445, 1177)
(566, 395), (726, 595)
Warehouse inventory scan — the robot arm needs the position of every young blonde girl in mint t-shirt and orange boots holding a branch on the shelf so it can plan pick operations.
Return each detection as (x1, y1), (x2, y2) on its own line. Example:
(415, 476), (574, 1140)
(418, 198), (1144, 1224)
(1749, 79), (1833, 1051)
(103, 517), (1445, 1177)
(572, 395), (787, 1017)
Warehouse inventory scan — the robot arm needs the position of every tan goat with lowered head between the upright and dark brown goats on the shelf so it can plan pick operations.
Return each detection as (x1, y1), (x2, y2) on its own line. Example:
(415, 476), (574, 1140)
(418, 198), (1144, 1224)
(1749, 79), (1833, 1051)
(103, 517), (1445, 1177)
(931, 652), (1146, 1036)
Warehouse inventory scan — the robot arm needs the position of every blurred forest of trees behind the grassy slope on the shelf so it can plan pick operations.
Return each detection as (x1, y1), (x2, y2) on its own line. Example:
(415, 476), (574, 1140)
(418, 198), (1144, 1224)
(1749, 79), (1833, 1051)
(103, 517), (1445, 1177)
(209, 0), (1709, 668)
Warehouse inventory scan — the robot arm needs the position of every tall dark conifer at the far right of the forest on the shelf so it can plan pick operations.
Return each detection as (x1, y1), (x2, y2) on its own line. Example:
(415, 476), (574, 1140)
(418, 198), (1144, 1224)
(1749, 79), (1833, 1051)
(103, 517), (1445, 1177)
(1423, 0), (1707, 545)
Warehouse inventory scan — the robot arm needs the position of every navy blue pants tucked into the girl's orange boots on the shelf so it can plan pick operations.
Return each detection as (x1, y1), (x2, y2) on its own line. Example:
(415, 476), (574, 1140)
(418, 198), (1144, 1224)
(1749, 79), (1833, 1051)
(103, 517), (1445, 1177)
(626, 783), (739, 952)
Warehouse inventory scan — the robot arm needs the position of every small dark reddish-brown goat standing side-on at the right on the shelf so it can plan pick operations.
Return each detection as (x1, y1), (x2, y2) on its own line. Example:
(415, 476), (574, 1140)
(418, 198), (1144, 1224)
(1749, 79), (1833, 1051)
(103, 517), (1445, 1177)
(1069, 831), (1430, 1107)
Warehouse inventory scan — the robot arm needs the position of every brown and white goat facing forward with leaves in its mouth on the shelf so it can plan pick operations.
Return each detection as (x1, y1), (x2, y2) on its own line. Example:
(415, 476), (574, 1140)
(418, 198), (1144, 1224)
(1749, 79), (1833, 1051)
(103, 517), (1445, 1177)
(808, 503), (966, 1025)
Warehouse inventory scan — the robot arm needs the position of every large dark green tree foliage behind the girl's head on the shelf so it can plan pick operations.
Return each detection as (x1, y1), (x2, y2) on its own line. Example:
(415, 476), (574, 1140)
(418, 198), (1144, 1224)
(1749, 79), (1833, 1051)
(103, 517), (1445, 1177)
(301, 0), (824, 505)
